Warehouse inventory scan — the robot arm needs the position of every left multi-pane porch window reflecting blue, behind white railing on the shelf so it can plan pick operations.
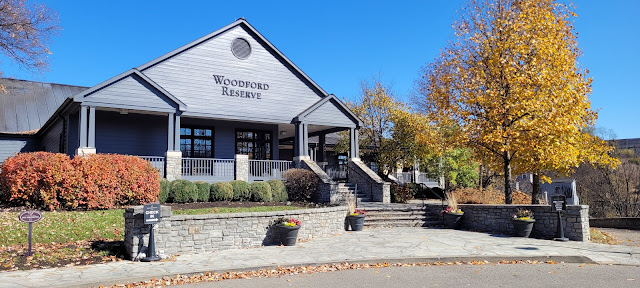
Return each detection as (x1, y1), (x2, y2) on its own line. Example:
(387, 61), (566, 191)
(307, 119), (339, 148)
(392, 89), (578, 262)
(180, 127), (214, 158)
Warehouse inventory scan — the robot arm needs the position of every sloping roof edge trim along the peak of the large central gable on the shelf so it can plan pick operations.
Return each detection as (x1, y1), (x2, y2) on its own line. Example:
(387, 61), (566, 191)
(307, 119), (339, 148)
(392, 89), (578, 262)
(138, 18), (328, 95)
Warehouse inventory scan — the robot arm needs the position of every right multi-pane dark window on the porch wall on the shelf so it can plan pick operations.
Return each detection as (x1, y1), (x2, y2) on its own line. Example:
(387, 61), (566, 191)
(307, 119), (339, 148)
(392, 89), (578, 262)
(236, 130), (273, 160)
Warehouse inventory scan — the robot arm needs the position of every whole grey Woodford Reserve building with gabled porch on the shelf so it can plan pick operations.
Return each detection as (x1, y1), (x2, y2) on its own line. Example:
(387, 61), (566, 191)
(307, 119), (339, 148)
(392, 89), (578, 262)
(0, 19), (388, 201)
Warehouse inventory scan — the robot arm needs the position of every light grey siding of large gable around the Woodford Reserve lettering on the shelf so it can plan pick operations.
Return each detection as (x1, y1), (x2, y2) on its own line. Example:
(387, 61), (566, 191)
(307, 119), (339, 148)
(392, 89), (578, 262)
(142, 26), (324, 123)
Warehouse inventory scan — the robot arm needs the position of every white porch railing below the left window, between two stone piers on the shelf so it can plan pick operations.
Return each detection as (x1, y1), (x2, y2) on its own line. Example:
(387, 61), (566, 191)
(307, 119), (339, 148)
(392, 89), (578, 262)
(182, 158), (235, 181)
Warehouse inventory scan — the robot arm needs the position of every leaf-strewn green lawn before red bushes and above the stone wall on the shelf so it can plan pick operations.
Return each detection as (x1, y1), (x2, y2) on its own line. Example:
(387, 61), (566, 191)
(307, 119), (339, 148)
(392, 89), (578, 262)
(0, 203), (306, 271)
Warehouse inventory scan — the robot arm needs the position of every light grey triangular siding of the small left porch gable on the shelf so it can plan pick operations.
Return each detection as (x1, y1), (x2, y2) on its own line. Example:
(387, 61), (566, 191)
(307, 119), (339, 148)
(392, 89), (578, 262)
(83, 75), (176, 112)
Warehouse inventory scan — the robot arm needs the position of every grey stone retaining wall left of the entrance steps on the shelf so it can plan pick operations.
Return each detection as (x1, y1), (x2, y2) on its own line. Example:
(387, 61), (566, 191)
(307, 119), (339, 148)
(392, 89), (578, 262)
(124, 206), (347, 259)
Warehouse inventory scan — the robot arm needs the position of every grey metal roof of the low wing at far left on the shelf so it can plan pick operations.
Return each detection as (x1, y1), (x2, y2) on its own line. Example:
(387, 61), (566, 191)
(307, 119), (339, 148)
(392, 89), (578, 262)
(0, 78), (87, 135)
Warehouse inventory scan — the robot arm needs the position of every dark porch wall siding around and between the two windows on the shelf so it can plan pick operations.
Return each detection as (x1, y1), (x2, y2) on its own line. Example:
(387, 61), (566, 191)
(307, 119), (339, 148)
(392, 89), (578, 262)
(180, 118), (279, 160)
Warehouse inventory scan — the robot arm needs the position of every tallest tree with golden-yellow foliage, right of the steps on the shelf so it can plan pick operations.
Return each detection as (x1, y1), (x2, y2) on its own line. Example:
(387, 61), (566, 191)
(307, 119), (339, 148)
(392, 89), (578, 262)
(418, 0), (616, 204)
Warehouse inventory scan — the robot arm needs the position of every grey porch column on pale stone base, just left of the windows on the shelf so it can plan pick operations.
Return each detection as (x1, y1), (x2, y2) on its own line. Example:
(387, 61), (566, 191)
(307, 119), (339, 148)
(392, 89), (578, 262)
(165, 113), (182, 181)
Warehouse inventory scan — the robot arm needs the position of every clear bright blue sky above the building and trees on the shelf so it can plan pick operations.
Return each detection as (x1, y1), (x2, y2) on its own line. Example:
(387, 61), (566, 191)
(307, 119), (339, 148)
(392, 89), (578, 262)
(0, 0), (640, 138)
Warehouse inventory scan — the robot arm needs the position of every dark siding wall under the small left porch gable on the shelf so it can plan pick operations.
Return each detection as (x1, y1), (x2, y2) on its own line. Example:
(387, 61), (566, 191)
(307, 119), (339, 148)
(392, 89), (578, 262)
(96, 111), (168, 156)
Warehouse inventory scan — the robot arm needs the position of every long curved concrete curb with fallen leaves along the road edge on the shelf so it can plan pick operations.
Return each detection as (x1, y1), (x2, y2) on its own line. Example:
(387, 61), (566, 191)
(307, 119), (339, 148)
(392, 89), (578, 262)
(72, 255), (597, 287)
